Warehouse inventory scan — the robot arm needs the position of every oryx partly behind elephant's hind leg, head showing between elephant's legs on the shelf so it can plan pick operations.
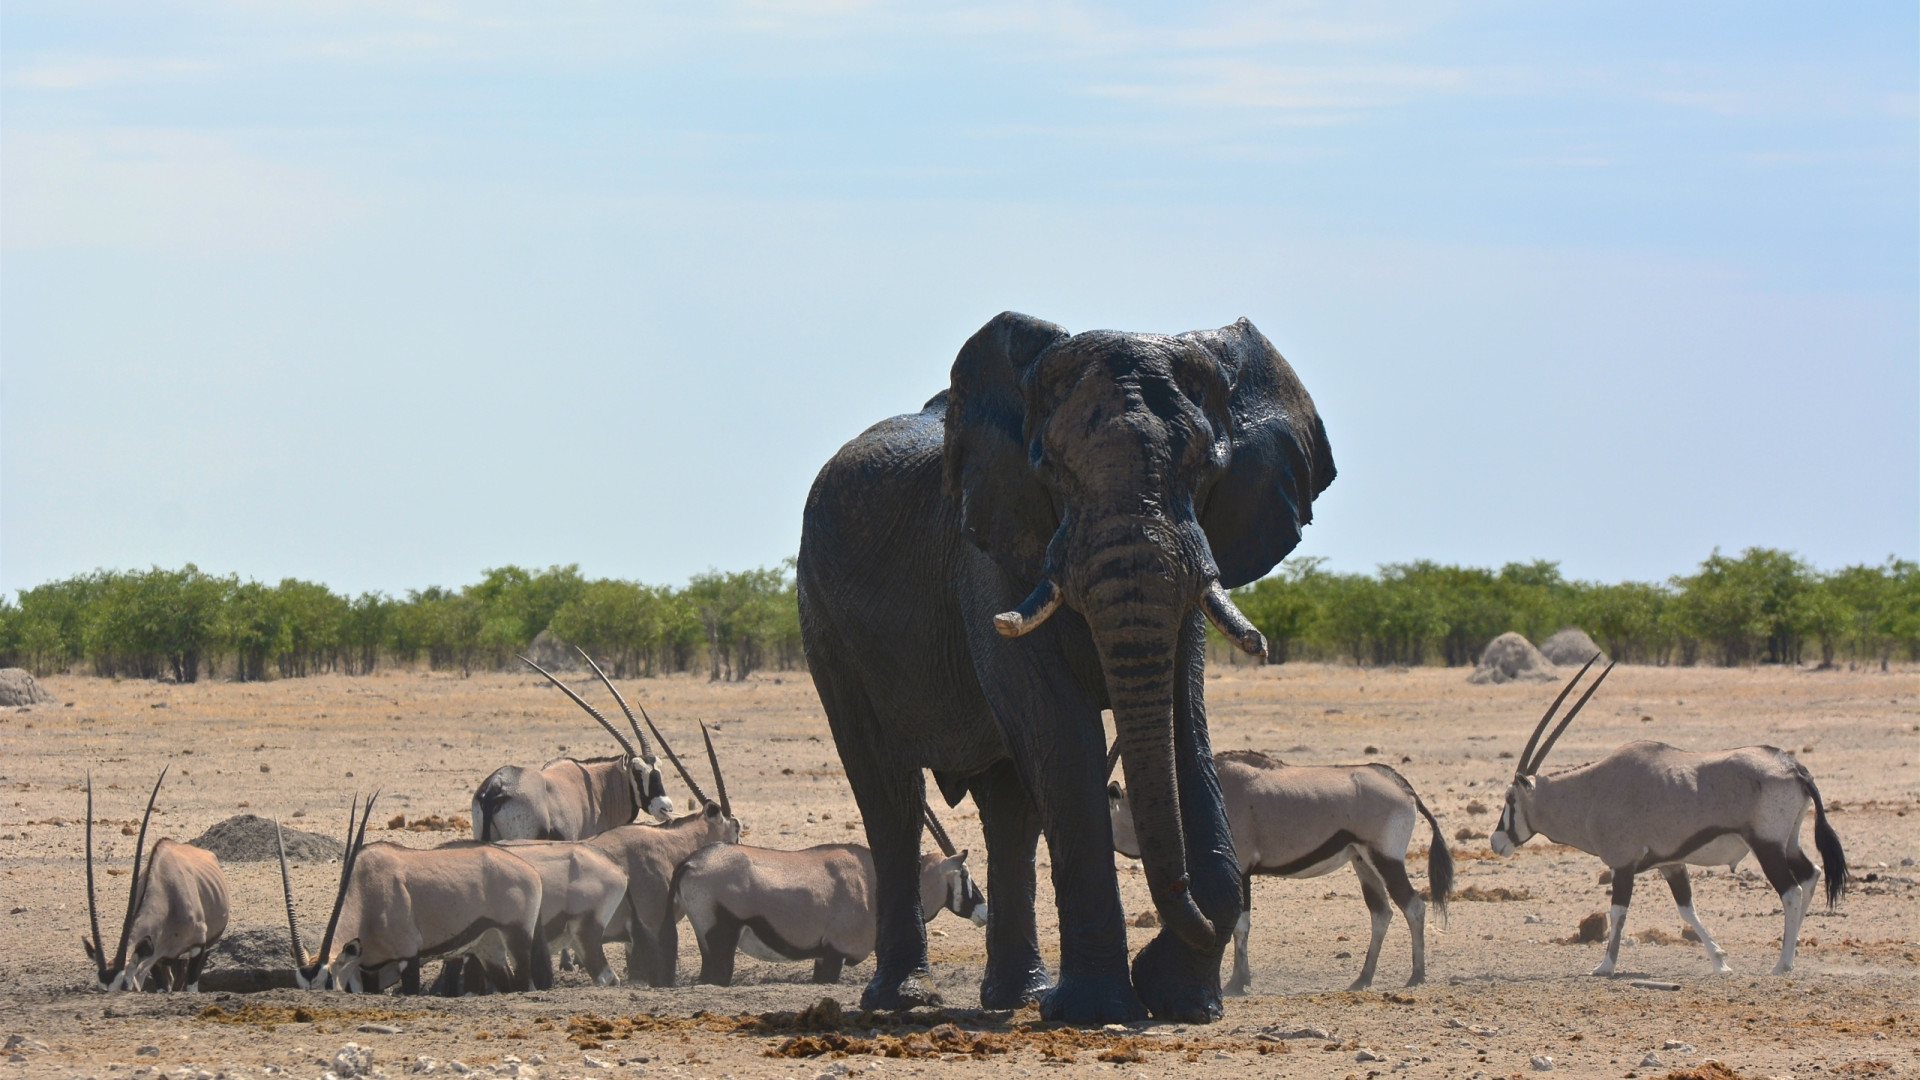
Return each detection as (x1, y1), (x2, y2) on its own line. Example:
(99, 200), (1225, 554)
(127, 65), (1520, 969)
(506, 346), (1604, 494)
(674, 807), (987, 986)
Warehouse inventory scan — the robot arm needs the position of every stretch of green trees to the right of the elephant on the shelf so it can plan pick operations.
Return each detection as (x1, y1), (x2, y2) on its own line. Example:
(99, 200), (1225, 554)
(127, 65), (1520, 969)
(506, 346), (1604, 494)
(1235, 548), (1920, 669)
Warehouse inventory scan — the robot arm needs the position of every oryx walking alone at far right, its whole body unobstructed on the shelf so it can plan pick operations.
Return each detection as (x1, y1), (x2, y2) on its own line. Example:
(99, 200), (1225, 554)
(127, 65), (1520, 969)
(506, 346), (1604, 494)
(1490, 653), (1847, 974)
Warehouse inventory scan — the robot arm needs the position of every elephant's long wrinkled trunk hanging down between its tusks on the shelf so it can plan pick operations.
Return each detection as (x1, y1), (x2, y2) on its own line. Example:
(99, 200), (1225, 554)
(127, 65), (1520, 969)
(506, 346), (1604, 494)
(1075, 536), (1215, 949)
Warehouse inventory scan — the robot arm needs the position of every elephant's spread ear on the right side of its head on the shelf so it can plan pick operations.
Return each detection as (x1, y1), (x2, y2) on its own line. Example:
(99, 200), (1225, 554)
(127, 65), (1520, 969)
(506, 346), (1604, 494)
(1181, 319), (1334, 588)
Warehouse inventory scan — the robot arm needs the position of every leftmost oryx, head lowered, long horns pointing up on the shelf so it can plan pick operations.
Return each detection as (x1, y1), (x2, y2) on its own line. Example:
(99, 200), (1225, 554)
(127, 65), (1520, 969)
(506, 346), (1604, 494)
(81, 769), (227, 990)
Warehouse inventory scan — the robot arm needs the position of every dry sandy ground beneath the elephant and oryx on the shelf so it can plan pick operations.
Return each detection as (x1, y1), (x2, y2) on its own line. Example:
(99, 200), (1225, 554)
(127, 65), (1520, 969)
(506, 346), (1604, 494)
(0, 665), (1920, 1080)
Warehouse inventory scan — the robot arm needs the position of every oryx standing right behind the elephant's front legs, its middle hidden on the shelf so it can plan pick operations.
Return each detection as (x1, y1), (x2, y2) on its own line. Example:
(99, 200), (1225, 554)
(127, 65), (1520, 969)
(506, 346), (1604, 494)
(1106, 746), (1453, 994)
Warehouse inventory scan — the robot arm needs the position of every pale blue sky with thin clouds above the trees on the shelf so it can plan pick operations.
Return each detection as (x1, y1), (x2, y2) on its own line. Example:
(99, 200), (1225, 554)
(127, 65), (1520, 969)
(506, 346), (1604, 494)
(0, 0), (1920, 590)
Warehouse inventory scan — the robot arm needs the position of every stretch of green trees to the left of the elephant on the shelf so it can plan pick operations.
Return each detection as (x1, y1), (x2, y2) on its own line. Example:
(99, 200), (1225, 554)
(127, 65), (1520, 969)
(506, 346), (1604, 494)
(0, 561), (803, 682)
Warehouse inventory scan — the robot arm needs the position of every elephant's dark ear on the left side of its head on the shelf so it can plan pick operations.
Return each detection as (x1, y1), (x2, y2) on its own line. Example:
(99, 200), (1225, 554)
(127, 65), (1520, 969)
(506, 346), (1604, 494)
(943, 311), (1068, 586)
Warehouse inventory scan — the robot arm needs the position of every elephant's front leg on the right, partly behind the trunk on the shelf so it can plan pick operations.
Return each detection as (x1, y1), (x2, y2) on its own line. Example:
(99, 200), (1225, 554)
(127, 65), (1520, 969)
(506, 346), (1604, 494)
(1133, 609), (1240, 1024)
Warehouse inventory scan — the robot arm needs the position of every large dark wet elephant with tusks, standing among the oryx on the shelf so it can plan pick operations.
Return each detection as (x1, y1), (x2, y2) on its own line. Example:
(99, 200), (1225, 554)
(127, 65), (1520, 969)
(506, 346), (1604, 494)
(795, 311), (1334, 1024)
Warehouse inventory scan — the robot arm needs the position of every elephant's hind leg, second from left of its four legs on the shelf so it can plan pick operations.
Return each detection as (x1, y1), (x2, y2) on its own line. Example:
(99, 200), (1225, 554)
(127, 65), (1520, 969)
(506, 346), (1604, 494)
(968, 761), (1050, 1009)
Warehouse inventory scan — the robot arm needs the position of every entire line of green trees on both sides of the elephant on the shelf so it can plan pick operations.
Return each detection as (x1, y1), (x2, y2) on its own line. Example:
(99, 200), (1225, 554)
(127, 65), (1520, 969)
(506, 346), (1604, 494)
(0, 548), (1920, 682)
